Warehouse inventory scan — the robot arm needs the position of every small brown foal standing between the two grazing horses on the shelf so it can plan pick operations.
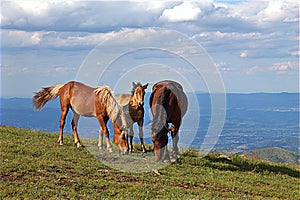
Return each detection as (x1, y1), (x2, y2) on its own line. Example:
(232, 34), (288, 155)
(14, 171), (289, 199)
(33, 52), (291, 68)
(117, 82), (148, 153)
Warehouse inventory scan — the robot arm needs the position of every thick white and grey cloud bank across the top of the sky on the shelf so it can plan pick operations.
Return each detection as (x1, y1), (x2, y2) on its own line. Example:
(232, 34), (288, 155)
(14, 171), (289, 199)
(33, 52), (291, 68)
(1, 0), (299, 33)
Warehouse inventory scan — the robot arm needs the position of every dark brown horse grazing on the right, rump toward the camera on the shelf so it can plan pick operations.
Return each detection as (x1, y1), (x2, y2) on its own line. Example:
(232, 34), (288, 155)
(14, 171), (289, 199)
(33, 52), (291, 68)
(150, 80), (188, 161)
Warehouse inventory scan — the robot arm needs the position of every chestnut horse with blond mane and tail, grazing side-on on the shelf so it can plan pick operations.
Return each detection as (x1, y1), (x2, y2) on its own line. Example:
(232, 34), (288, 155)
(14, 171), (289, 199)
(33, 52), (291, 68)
(33, 81), (128, 154)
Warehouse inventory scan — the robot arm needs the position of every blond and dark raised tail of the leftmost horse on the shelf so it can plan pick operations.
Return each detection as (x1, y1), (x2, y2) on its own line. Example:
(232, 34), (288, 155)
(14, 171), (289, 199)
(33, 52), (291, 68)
(32, 84), (65, 110)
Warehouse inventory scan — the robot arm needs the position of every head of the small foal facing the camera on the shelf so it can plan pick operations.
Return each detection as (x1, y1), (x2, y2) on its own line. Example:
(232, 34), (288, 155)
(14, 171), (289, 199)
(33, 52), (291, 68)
(130, 82), (148, 108)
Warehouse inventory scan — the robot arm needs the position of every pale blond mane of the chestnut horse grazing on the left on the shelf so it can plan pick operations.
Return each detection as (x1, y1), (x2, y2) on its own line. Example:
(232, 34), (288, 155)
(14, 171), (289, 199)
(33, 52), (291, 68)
(94, 86), (122, 122)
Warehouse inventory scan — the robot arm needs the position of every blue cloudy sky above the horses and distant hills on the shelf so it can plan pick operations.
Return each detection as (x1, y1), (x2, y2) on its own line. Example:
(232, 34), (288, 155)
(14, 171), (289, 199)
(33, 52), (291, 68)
(1, 0), (299, 98)
